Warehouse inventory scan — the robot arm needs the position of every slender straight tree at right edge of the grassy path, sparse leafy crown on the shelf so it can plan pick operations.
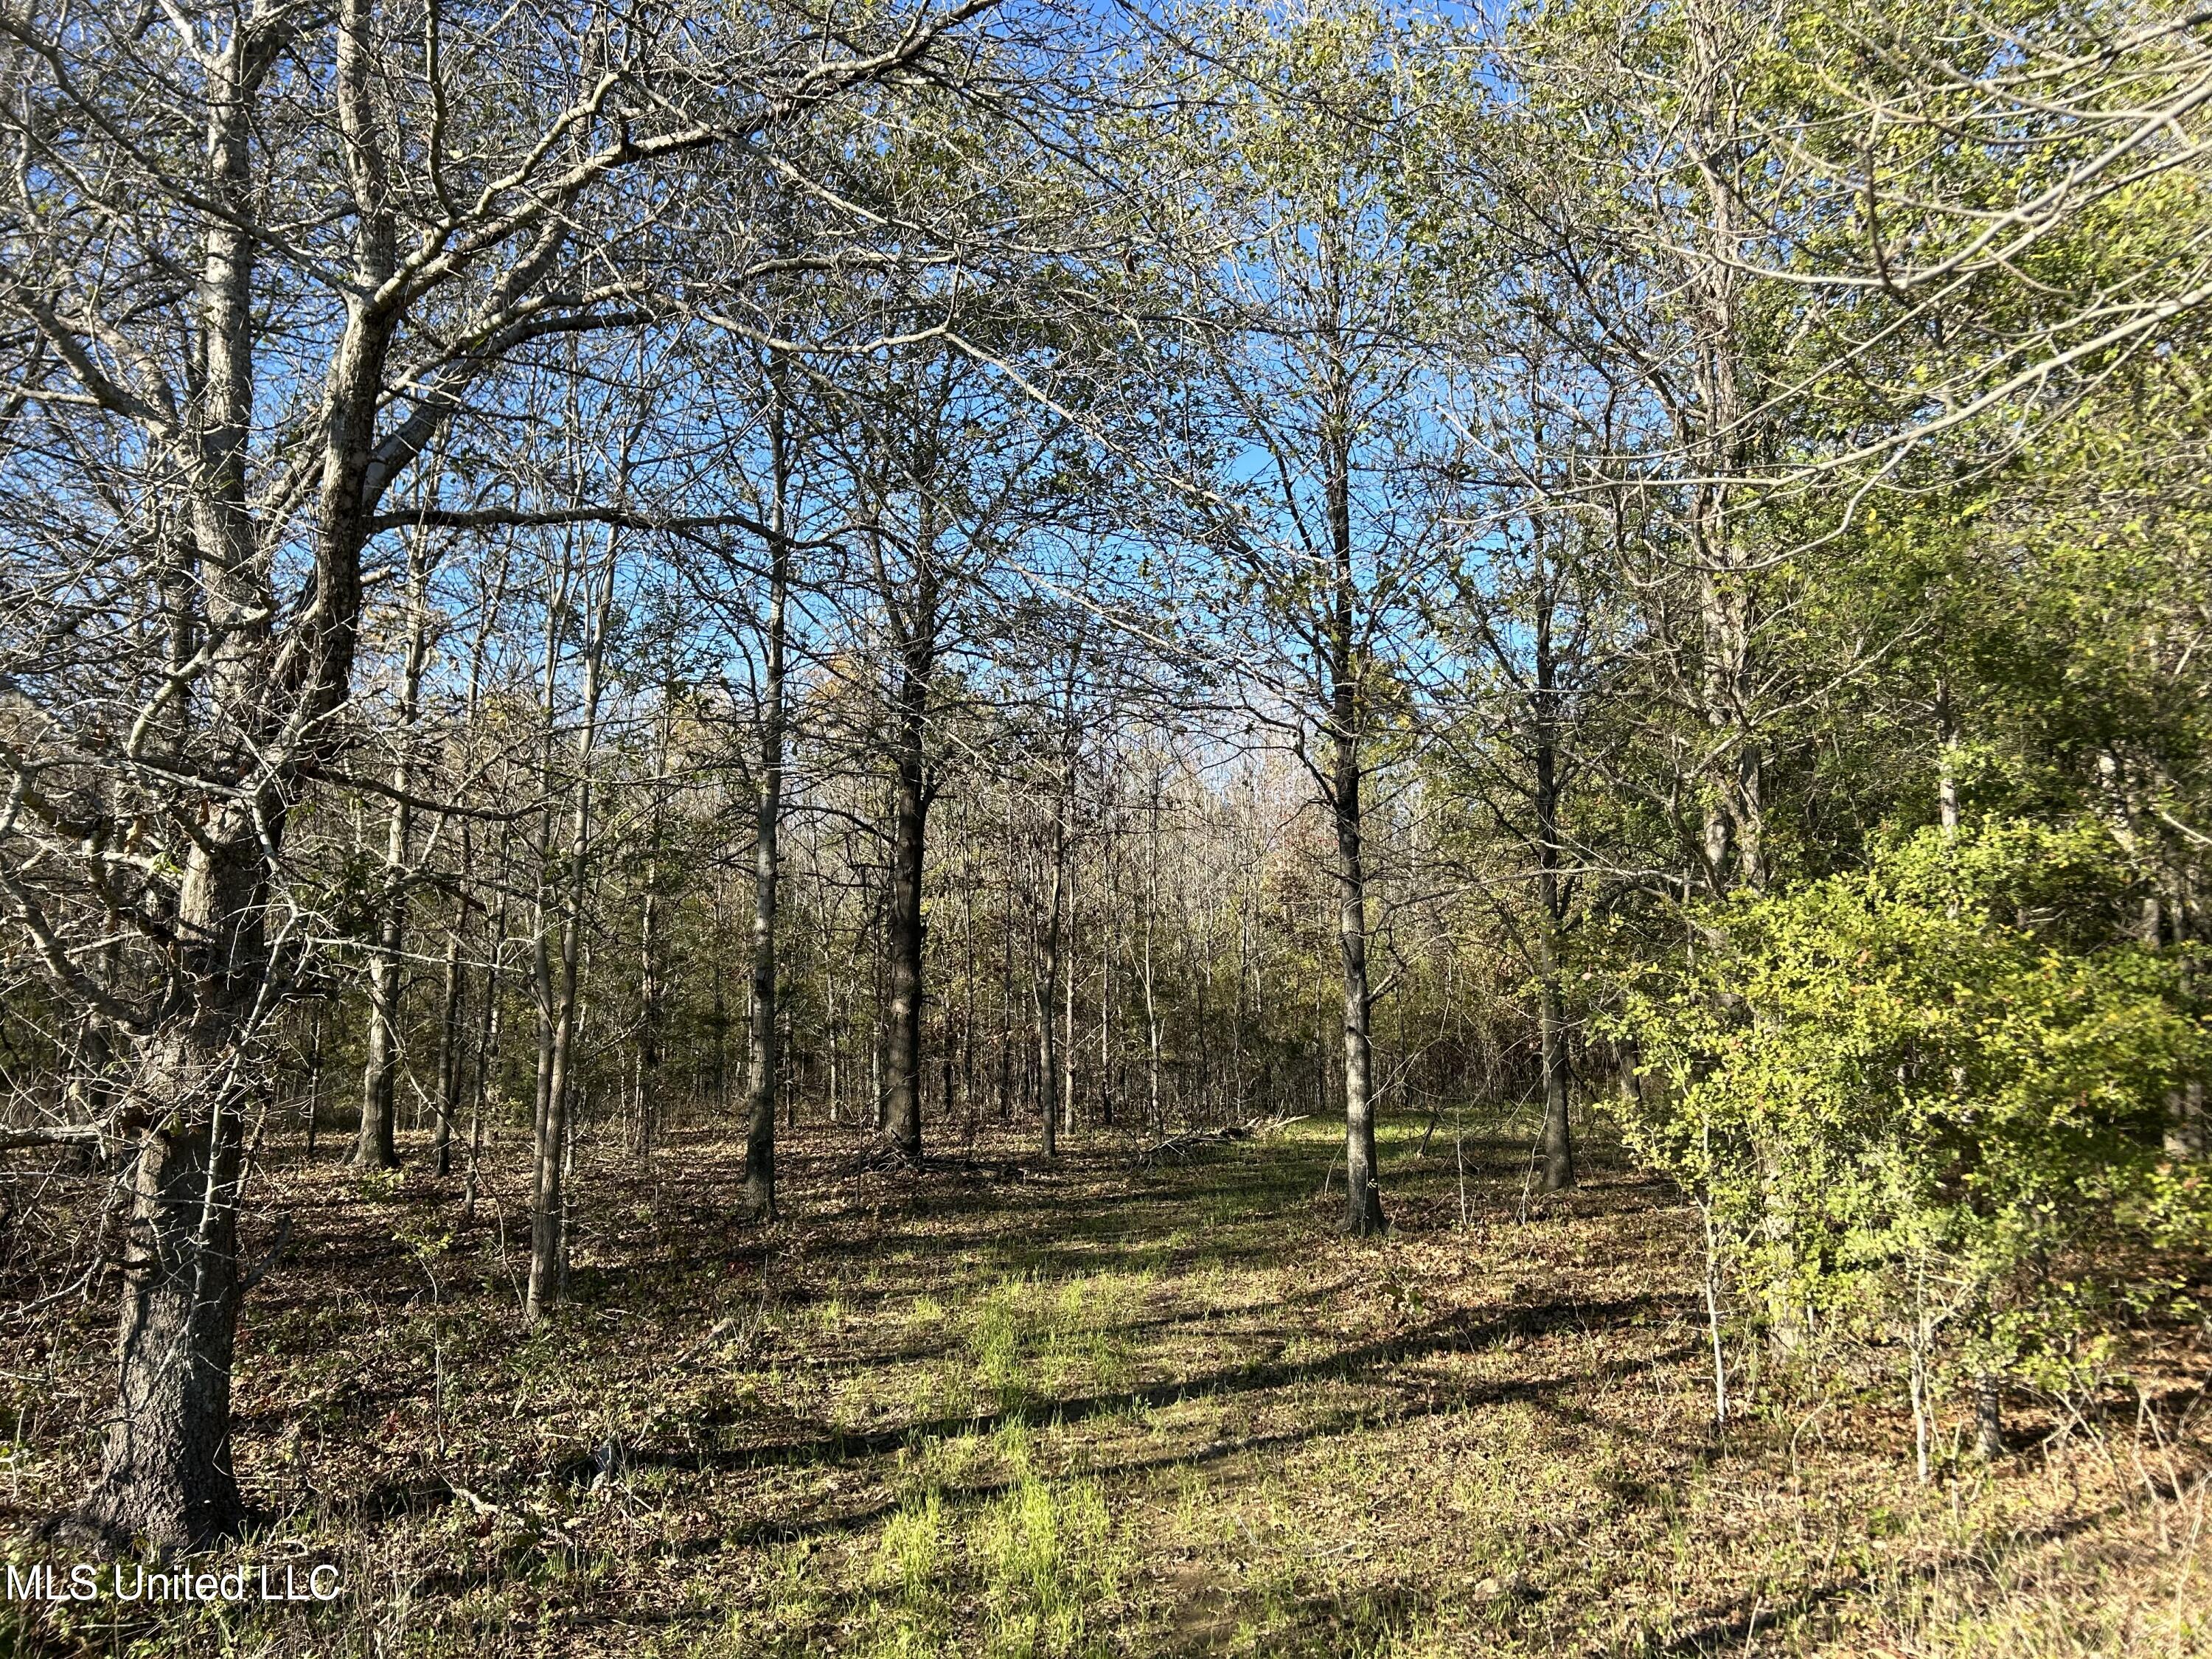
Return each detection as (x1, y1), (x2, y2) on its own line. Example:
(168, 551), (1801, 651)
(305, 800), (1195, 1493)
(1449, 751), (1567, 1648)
(1159, 7), (1440, 1234)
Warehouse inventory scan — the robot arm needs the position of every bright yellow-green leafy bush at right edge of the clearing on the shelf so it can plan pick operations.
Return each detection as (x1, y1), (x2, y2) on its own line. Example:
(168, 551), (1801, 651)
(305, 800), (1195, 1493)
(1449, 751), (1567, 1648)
(1619, 823), (2212, 1451)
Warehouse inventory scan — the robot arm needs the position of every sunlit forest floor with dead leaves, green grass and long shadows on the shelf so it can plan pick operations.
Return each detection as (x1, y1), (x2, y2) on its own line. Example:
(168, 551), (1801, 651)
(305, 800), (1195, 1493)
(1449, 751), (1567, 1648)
(0, 1117), (2212, 1659)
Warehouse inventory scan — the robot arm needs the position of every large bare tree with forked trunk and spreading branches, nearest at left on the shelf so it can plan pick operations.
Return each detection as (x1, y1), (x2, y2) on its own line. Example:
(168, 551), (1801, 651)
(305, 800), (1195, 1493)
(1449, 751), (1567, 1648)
(0, 0), (989, 1540)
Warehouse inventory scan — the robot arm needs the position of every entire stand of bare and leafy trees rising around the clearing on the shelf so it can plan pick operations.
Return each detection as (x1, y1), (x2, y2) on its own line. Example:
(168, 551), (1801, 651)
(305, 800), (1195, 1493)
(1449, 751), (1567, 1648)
(0, 0), (2212, 1540)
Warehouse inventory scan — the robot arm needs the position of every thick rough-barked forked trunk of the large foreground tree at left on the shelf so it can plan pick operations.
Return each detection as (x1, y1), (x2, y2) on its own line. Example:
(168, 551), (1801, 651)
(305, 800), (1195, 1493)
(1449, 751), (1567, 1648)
(80, 0), (392, 1546)
